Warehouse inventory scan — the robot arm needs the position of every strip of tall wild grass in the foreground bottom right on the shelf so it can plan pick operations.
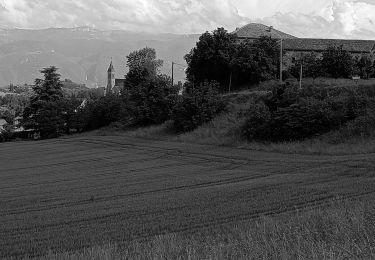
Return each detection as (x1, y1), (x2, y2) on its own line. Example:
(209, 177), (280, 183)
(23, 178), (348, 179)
(34, 200), (375, 260)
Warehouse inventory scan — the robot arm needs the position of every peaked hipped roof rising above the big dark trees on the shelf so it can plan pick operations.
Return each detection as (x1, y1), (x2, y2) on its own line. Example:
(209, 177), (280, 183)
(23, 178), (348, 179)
(233, 23), (296, 39)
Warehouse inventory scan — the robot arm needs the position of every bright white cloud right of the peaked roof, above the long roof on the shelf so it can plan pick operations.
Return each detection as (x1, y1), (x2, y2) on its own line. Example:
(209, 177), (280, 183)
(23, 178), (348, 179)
(257, 0), (375, 39)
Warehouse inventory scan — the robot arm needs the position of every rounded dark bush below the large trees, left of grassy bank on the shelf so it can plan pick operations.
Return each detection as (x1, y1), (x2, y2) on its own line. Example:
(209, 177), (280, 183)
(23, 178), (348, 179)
(172, 81), (224, 132)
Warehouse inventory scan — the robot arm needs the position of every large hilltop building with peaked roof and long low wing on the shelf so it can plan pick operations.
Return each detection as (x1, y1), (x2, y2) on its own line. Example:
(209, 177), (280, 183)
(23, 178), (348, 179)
(233, 23), (375, 67)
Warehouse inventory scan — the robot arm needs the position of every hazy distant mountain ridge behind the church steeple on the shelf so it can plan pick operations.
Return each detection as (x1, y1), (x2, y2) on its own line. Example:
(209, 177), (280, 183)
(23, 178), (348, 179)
(0, 27), (199, 87)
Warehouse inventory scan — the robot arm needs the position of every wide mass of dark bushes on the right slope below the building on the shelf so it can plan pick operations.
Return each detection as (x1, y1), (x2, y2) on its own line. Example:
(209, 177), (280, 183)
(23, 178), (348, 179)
(243, 86), (375, 142)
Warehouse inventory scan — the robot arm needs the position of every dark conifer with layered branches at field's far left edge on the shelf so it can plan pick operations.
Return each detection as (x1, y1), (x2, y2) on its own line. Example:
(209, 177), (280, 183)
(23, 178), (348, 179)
(23, 66), (65, 138)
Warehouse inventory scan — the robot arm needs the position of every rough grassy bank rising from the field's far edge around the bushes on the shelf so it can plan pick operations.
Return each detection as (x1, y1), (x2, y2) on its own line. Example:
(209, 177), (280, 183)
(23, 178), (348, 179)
(115, 79), (375, 155)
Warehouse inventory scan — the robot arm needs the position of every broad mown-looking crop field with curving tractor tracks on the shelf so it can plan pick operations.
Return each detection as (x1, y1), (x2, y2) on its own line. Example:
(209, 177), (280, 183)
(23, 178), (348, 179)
(0, 136), (375, 258)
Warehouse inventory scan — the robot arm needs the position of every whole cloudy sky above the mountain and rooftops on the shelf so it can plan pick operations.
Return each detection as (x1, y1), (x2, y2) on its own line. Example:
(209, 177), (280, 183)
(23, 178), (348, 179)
(0, 0), (375, 39)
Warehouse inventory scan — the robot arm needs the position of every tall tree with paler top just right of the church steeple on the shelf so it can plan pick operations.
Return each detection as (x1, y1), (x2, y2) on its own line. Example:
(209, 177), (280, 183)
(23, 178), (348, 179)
(121, 48), (177, 126)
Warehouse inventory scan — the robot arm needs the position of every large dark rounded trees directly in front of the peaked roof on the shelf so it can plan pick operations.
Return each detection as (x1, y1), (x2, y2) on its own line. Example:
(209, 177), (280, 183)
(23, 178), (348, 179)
(185, 28), (280, 91)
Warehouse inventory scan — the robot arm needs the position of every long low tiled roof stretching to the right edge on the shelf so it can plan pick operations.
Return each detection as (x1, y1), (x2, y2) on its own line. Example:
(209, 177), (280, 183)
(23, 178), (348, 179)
(283, 38), (375, 53)
